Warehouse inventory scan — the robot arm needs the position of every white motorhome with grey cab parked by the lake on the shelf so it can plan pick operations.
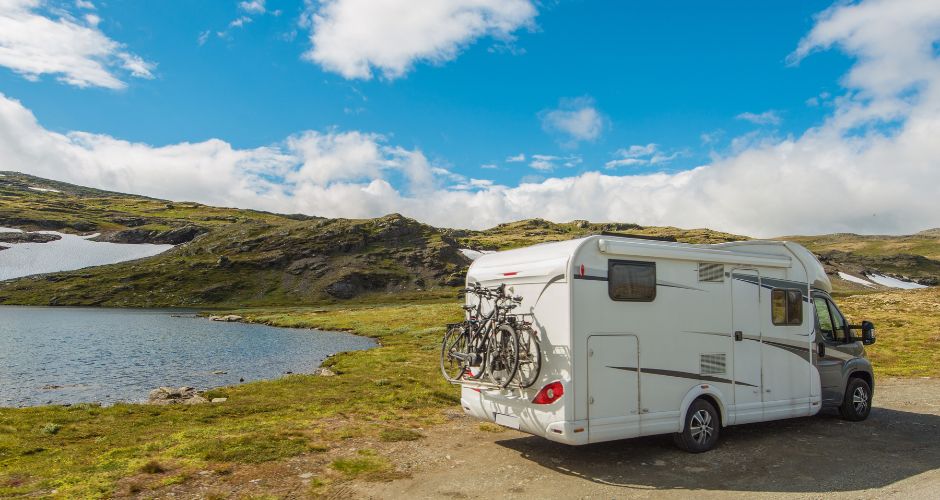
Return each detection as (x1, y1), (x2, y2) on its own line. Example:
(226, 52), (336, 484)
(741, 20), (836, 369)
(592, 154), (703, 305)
(461, 234), (875, 452)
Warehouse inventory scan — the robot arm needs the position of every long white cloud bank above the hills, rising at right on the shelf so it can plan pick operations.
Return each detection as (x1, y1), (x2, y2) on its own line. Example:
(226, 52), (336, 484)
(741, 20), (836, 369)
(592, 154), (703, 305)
(0, 0), (940, 236)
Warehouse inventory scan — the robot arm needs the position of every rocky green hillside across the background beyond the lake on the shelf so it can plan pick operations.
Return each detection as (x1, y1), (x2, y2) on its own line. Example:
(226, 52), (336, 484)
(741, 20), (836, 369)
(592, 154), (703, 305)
(0, 172), (940, 307)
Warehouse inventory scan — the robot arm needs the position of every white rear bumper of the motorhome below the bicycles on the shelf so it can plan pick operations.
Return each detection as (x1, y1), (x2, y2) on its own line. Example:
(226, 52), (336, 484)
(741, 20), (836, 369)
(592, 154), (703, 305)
(460, 388), (588, 445)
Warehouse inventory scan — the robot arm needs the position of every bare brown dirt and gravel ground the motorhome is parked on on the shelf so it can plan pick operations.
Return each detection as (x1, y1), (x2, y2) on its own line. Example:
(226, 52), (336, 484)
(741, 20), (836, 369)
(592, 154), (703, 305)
(162, 379), (940, 499)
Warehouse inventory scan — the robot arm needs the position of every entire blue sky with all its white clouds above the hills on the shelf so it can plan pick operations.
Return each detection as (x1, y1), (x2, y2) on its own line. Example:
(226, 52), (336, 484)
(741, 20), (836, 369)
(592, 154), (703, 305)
(0, 0), (940, 236)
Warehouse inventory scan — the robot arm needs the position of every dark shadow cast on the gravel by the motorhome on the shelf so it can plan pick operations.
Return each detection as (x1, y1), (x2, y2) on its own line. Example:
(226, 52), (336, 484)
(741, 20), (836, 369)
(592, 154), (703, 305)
(497, 408), (940, 493)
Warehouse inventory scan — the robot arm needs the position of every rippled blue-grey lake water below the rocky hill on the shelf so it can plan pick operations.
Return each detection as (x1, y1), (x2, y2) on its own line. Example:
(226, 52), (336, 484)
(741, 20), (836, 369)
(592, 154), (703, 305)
(0, 306), (375, 406)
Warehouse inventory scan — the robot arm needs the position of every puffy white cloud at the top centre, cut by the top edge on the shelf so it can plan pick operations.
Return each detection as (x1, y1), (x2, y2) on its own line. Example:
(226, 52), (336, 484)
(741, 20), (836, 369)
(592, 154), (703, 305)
(301, 0), (537, 79)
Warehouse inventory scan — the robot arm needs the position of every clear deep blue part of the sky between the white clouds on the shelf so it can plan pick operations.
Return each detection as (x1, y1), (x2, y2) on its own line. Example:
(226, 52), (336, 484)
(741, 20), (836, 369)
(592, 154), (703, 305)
(0, 1), (848, 182)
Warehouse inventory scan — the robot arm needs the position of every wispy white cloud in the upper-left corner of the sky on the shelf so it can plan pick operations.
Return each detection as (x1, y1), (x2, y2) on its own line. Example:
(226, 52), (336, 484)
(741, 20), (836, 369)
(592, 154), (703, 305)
(0, 0), (155, 89)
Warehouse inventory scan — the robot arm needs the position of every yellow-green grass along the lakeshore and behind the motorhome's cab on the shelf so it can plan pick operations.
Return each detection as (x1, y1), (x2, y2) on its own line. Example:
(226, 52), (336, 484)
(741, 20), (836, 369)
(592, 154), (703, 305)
(0, 289), (940, 496)
